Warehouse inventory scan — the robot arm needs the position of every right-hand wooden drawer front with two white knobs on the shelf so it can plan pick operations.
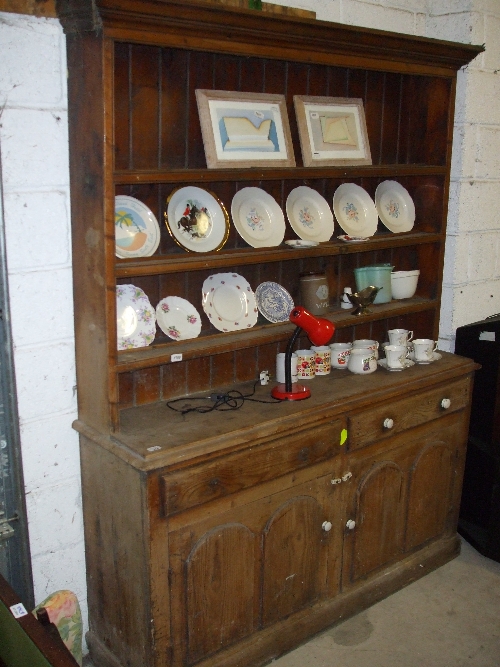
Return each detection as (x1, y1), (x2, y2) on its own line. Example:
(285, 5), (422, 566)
(348, 379), (470, 450)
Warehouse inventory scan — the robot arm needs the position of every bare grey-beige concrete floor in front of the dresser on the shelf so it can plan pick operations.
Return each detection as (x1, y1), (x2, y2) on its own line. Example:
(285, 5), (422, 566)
(84, 541), (500, 667)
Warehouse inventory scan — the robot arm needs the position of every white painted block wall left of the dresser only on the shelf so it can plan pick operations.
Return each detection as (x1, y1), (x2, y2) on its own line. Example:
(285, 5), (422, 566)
(0, 12), (86, 628)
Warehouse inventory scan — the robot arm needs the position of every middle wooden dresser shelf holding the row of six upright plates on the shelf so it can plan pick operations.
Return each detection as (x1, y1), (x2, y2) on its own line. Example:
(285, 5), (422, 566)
(115, 230), (443, 278)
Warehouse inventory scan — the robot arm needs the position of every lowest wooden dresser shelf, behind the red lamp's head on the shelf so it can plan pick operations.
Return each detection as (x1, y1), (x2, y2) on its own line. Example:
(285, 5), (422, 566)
(115, 297), (439, 373)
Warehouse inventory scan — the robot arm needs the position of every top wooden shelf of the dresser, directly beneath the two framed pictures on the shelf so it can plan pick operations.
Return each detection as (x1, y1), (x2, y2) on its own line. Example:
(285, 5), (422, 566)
(114, 164), (446, 185)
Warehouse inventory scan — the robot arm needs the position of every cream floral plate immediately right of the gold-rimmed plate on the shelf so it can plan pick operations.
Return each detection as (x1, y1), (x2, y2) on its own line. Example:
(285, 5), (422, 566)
(231, 188), (285, 248)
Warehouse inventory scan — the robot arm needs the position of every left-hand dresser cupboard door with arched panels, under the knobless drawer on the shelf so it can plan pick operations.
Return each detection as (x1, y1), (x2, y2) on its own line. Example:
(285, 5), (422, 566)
(169, 475), (342, 666)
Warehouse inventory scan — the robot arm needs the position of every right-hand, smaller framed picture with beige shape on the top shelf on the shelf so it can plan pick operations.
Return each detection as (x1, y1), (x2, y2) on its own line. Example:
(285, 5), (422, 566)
(293, 95), (372, 167)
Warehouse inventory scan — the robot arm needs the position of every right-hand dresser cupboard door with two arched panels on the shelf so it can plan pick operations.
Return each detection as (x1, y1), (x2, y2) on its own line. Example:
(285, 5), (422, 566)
(342, 412), (466, 587)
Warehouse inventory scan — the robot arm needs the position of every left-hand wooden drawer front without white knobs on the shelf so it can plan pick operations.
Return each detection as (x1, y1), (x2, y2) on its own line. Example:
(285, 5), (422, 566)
(161, 420), (343, 515)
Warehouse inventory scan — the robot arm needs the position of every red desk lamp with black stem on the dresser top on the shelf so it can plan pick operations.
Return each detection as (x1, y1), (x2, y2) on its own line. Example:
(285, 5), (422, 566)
(271, 306), (335, 401)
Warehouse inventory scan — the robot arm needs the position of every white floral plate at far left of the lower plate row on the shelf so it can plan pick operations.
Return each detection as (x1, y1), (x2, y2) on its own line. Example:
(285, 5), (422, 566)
(116, 285), (156, 350)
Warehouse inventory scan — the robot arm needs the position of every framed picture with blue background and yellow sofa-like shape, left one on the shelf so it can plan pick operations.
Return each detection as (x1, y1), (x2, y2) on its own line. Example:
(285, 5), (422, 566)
(196, 90), (295, 169)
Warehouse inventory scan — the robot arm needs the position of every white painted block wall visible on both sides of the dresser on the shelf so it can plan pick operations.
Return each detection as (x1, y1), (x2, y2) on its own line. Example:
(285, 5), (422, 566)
(0, 0), (500, 656)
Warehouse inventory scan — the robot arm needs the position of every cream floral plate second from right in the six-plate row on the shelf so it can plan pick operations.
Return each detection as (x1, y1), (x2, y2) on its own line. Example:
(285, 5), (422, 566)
(333, 183), (378, 237)
